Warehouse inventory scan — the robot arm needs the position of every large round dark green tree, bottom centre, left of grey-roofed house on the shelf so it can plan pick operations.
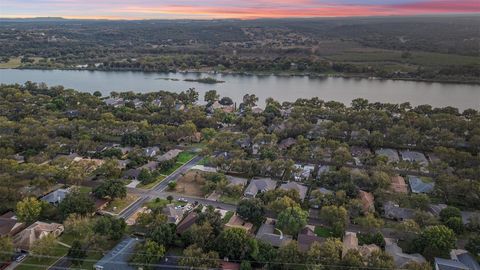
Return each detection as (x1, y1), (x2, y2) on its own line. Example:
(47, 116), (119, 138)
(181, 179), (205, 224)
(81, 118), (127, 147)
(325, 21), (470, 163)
(215, 228), (258, 260)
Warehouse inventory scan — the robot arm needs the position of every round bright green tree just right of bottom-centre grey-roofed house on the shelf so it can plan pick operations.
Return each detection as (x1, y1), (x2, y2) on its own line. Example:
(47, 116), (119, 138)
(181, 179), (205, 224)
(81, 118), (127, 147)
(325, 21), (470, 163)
(277, 206), (308, 235)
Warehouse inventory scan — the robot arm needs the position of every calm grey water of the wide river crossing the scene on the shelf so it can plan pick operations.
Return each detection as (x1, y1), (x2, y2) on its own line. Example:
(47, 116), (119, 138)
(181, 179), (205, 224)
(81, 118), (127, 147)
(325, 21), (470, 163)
(0, 69), (480, 110)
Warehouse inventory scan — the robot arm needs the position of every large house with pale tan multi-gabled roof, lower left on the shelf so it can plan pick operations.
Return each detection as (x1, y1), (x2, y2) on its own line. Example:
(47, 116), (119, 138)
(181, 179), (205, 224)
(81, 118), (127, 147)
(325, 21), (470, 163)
(13, 221), (65, 251)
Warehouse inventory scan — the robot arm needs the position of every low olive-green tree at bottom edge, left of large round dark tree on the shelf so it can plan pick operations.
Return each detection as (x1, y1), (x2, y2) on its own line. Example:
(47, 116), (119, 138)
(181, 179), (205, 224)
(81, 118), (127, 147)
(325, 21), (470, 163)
(178, 245), (220, 269)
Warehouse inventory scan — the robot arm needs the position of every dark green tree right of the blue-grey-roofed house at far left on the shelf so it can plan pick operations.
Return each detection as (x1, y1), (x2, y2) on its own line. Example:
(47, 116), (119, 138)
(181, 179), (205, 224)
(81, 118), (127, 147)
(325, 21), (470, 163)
(58, 191), (95, 218)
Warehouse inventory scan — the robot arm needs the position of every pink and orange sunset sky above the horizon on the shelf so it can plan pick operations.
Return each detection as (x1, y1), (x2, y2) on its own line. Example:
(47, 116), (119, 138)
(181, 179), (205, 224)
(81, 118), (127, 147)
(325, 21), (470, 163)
(0, 0), (480, 20)
